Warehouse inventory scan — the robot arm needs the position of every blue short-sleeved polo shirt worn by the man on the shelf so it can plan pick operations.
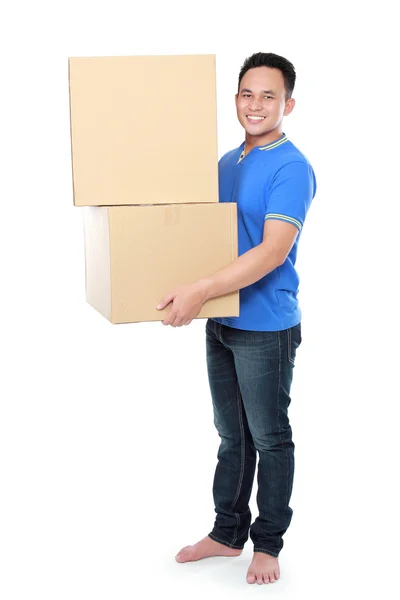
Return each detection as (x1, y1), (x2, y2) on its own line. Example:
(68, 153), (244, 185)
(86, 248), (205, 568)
(214, 134), (316, 331)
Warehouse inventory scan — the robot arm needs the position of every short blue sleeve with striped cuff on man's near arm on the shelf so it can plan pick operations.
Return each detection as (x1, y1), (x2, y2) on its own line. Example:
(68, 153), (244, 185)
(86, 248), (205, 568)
(265, 161), (316, 231)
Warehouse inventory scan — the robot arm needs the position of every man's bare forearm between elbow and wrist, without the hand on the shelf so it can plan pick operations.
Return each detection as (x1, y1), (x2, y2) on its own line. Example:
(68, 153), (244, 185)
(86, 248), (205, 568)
(198, 244), (285, 300)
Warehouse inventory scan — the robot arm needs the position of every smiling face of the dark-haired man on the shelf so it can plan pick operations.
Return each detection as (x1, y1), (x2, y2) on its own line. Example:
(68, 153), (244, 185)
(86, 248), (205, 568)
(235, 67), (294, 139)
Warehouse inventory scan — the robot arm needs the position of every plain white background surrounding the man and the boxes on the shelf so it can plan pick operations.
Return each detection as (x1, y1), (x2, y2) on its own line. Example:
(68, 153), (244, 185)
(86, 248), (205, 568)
(0, 0), (400, 600)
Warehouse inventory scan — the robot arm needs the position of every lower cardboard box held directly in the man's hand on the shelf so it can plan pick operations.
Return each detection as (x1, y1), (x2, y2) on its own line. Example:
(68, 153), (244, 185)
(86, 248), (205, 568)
(83, 203), (239, 323)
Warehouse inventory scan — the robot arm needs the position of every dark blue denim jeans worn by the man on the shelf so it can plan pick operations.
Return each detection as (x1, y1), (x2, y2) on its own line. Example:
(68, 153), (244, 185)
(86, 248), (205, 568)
(206, 319), (301, 556)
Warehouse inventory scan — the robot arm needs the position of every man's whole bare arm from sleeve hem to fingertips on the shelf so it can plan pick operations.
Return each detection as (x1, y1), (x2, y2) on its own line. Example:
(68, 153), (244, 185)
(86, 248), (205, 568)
(157, 220), (298, 327)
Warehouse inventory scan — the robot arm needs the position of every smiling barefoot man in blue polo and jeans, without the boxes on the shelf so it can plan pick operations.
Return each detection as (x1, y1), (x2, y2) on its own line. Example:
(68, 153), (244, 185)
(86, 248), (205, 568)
(157, 52), (316, 584)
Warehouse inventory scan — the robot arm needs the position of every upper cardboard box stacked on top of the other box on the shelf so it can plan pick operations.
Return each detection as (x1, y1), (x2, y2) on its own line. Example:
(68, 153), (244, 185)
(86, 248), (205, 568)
(69, 55), (218, 206)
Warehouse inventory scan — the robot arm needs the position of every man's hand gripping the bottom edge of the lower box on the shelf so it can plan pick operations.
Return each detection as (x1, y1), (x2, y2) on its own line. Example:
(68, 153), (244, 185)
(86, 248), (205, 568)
(157, 282), (207, 327)
